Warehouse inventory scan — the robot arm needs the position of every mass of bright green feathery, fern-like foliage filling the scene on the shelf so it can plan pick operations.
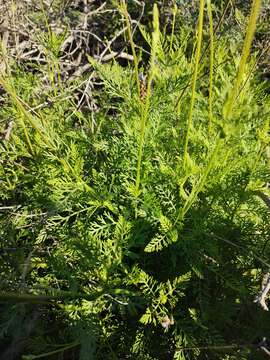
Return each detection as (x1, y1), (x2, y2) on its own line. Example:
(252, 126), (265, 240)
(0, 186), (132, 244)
(0, 2), (270, 360)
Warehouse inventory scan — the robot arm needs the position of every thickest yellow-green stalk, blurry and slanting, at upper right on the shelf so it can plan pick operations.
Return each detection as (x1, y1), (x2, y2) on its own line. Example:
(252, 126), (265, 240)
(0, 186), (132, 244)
(224, 0), (261, 119)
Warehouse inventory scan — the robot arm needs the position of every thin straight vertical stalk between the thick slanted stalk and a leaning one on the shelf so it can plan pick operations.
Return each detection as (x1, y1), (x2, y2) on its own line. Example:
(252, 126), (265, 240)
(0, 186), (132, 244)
(207, 0), (214, 132)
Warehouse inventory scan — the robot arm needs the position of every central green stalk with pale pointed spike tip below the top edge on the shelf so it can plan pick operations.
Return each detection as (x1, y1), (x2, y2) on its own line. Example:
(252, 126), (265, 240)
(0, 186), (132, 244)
(136, 4), (159, 194)
